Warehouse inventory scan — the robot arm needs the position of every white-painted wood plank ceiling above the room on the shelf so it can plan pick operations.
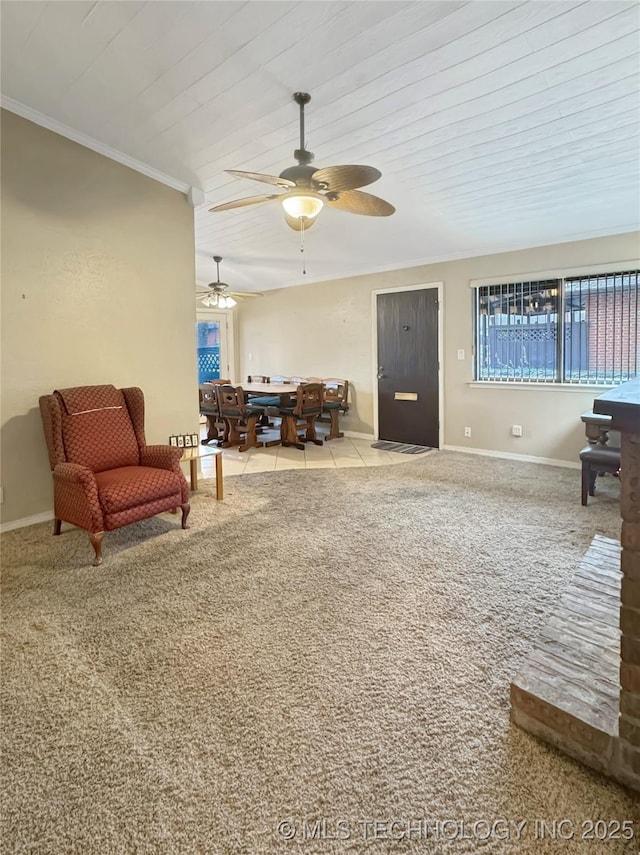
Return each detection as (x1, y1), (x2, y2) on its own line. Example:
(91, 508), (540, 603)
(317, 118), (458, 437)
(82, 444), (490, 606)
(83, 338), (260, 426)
(1, 0), (640, 291)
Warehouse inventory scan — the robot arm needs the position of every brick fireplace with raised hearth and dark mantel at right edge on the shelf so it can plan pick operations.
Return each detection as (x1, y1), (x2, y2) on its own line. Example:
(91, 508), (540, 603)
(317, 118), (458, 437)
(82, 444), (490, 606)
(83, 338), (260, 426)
(511, 377), (640, 791)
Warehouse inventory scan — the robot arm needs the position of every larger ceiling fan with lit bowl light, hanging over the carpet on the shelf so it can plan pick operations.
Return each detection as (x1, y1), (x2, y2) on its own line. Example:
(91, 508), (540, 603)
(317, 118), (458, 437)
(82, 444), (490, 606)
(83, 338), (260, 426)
(209, 92), (395, 232)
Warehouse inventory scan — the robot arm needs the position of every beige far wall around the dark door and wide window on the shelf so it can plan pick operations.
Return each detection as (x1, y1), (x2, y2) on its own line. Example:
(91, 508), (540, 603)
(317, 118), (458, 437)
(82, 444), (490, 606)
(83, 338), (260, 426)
(238, 233), (640, 462)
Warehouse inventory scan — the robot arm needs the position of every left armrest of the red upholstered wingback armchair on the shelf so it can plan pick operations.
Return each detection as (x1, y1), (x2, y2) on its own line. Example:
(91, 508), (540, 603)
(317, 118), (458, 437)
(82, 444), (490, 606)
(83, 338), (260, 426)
(53, 463), (104, 532)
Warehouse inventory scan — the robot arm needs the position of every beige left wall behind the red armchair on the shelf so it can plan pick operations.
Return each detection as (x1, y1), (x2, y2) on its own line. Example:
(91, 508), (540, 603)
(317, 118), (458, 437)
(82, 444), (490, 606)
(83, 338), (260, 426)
(0, 111), (198, 523)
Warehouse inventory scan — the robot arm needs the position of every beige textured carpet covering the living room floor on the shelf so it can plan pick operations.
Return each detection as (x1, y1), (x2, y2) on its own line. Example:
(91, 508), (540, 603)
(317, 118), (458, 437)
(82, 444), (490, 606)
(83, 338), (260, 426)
(2, 452), (640, 855)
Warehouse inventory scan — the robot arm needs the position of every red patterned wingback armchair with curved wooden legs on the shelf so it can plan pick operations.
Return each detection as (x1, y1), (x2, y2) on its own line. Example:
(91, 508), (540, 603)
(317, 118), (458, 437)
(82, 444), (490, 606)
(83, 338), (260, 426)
(40, 386), (190, 566)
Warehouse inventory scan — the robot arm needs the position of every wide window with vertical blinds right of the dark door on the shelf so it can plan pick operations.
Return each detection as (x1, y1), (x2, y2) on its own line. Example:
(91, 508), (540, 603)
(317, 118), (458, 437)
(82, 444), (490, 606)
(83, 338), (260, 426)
(474, 270), (640, 386)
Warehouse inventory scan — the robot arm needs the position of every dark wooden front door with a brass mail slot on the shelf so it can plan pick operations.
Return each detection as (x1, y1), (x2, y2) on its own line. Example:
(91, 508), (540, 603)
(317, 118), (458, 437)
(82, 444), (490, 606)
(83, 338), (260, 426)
(377, 288), (439, 448)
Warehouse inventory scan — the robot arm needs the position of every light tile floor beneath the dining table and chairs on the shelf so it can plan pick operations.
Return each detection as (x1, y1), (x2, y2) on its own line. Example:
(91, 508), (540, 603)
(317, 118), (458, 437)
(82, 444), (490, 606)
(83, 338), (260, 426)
(200, 425), (411, 478)
